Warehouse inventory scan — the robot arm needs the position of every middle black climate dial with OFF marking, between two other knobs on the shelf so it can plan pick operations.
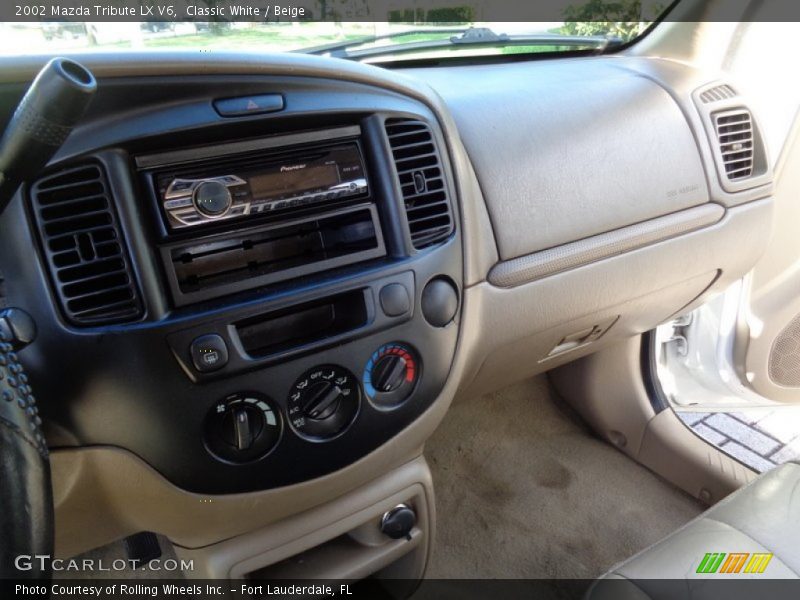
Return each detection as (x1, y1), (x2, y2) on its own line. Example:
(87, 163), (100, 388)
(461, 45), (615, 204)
(287, 365), (361, 440)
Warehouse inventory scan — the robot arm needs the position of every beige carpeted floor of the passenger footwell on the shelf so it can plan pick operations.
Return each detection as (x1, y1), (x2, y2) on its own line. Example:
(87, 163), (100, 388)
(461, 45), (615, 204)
(425, 376), (703, 579)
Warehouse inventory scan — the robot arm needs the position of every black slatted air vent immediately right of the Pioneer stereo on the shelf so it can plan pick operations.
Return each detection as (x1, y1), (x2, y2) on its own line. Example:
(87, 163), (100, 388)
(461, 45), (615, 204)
(386, 119), (453, 250)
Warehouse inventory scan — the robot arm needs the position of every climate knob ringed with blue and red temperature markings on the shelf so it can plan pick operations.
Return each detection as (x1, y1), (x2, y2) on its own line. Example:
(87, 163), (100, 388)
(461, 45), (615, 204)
(363, 343), (419, 409)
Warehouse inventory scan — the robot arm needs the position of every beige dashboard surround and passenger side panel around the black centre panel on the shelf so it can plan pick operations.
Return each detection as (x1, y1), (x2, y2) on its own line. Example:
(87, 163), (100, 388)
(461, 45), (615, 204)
(2, 48), (772, 576)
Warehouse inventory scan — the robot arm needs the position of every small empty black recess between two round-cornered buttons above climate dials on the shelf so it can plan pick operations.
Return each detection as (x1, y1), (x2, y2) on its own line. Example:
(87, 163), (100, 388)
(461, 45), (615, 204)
(235, 289), (369, 358)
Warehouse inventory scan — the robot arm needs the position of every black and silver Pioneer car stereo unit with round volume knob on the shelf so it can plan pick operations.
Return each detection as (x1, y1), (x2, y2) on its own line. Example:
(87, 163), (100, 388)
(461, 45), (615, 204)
(155, 142), (368, 230)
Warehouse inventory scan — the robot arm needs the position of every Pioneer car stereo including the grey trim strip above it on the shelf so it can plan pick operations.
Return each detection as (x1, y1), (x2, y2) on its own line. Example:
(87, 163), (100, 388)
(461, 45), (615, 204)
(136, 126), (370, 235)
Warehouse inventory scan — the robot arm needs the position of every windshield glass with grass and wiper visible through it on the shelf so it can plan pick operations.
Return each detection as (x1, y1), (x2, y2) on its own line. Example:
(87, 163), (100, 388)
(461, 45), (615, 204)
(0, 0), (663, 62)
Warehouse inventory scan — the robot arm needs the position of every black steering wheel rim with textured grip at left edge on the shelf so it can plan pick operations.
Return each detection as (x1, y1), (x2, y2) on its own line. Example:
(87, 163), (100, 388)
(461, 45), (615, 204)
(0, 328), (53, 579)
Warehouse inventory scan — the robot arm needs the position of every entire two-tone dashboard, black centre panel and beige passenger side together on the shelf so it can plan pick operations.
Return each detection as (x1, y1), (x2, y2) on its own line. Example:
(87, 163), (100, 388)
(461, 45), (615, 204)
(0, 48), (771, 568)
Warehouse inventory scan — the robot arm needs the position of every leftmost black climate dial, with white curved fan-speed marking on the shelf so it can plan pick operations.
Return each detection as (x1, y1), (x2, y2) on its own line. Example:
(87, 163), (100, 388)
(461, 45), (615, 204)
(205, 393), (281, 463)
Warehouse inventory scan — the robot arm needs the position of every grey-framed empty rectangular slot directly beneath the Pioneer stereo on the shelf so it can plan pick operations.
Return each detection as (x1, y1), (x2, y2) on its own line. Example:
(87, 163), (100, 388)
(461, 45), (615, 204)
(163, 205), (386, 306)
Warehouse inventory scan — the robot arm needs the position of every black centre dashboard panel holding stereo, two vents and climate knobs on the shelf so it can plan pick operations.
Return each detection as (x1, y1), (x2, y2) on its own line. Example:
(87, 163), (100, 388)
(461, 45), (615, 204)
(17, 75), (462, 494)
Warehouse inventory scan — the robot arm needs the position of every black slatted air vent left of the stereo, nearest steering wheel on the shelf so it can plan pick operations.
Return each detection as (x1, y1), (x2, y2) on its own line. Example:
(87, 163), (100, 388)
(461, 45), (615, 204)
(31, 165), (142, 325)
